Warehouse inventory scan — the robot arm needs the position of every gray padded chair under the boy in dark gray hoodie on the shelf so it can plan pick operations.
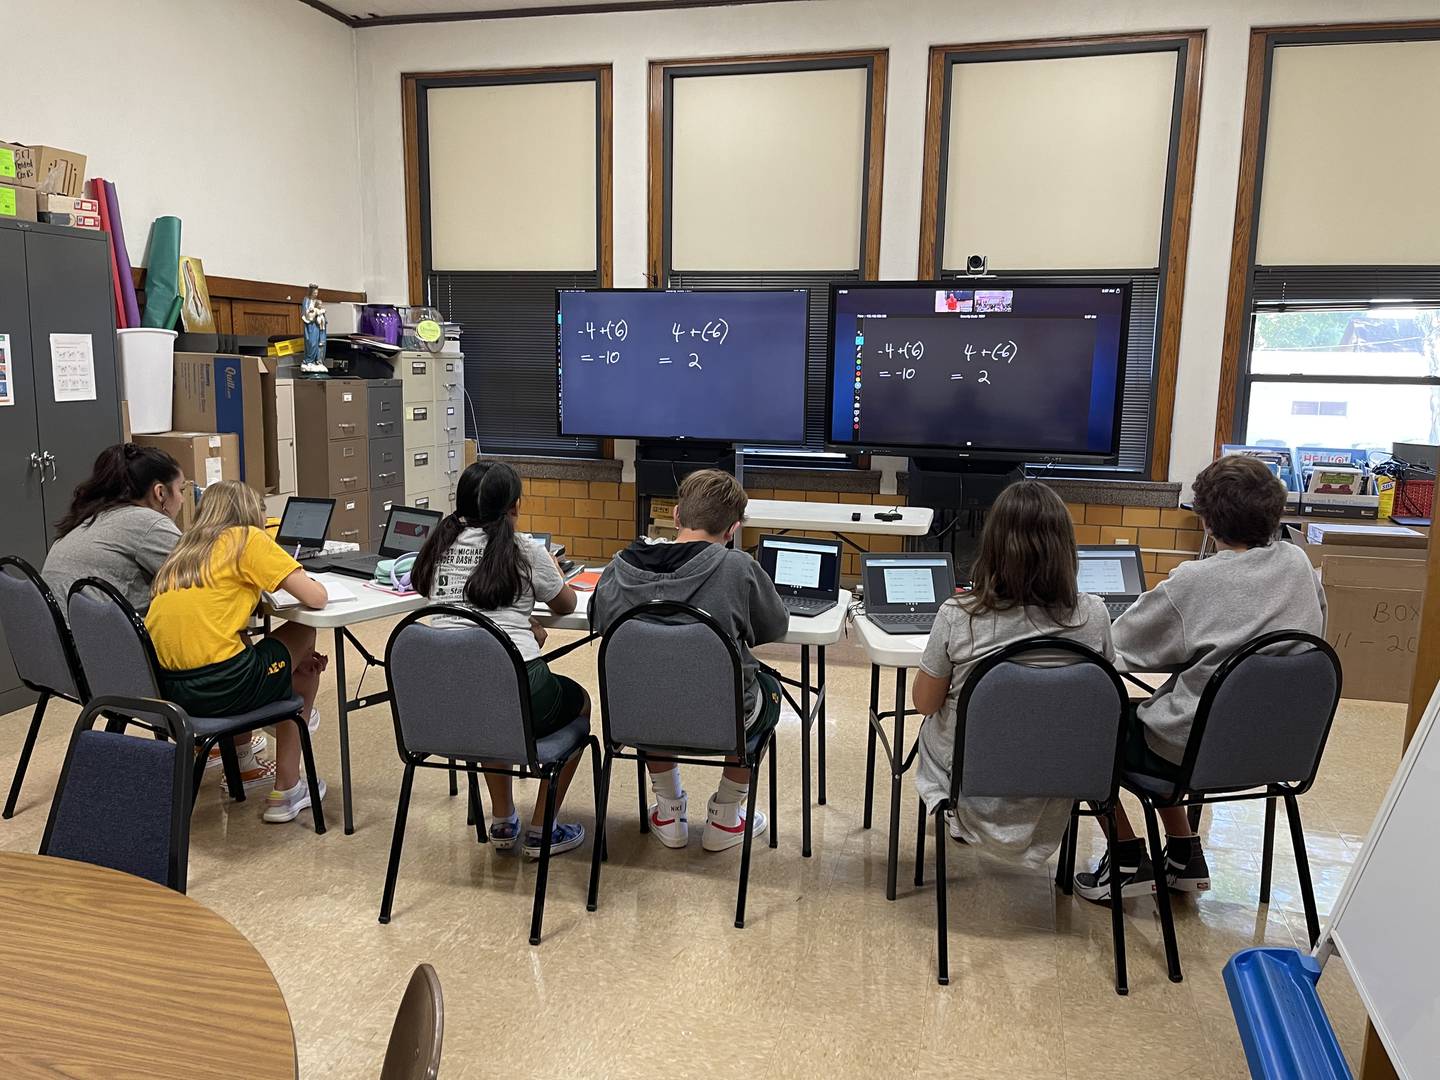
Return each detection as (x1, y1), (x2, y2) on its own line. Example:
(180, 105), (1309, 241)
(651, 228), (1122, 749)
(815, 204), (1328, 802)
(586, 600), (779, 929)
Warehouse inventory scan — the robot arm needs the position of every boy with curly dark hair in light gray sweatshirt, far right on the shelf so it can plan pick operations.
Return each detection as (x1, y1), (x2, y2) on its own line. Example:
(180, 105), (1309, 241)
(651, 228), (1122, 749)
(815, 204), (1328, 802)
(1076, 455), (1325, 901)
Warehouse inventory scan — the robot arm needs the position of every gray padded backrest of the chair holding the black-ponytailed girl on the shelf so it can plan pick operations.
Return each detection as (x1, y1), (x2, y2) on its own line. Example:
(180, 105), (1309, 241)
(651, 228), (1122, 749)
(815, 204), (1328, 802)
(387, 622), (530, 765)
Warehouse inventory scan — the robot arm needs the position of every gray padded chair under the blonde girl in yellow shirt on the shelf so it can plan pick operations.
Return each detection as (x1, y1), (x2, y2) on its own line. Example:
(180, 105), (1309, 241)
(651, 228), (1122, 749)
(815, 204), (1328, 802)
(68, 577), (325, 832)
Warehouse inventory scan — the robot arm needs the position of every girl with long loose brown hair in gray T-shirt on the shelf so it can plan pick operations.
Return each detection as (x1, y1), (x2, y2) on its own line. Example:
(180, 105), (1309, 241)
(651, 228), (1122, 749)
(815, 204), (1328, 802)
(913, 480), (1115, 865)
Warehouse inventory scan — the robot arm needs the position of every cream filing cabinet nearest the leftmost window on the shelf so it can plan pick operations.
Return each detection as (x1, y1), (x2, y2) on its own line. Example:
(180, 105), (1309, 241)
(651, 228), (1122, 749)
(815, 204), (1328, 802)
(395, 350), (465, 514)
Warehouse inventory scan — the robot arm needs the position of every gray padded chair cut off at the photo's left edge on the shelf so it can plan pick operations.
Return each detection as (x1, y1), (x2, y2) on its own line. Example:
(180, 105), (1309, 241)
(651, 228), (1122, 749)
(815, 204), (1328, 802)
(0, 554), (88, 818)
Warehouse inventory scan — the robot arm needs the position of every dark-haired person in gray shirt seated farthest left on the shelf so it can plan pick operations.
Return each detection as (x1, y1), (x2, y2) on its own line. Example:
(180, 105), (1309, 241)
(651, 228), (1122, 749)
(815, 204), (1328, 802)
(42, 442), (184, 613)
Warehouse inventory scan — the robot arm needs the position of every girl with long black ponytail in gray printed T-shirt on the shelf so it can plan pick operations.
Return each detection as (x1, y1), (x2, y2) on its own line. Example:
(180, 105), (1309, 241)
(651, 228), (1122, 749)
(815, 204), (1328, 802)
(410, 462), (590, 858)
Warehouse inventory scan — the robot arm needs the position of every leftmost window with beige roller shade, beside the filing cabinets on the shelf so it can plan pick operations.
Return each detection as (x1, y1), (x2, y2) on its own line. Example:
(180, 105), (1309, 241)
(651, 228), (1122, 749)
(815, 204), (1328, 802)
(415, 68), (609, 458)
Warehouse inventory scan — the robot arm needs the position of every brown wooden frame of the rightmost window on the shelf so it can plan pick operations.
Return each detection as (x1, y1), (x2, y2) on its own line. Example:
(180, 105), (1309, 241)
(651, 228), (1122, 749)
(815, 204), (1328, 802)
(1214, 19), (1440, 454)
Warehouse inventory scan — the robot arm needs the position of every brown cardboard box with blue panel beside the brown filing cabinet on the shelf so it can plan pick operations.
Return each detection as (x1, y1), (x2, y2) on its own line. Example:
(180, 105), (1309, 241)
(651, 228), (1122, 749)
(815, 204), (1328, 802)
(173, 353), (279, 495)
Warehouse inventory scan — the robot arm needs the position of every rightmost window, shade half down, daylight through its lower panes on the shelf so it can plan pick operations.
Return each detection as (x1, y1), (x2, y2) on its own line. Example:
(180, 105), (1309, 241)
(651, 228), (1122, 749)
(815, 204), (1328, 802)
(1221, 26), (1440, 456)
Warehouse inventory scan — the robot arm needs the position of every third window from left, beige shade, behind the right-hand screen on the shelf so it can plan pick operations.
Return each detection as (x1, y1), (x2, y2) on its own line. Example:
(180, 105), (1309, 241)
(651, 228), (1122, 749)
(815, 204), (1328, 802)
(920, 35), (1200, 480)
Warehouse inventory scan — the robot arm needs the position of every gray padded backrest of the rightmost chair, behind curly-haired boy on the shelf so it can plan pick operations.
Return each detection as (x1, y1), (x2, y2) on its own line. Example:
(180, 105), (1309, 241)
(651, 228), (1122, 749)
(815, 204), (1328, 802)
(1189, 648), (1336, 791)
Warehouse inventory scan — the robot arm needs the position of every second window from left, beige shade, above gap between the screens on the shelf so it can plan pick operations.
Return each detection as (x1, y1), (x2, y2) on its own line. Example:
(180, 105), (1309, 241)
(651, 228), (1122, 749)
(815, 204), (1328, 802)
(651, 52), (886, 464)
